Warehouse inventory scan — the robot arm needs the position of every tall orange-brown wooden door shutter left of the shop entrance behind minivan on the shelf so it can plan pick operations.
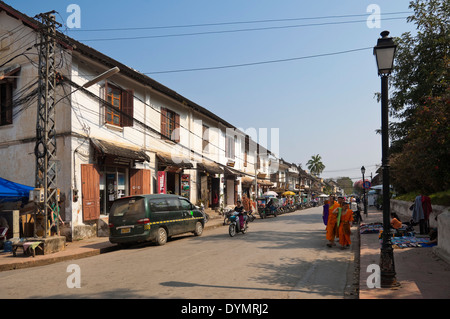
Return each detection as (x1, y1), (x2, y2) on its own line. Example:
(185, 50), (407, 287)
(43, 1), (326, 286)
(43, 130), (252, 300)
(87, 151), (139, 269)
(81, 164), (100, 221)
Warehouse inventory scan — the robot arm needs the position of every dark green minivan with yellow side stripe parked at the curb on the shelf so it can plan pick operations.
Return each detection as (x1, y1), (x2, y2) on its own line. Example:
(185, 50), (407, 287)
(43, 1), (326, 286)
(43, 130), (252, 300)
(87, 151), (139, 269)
(109, 194), (205, 246)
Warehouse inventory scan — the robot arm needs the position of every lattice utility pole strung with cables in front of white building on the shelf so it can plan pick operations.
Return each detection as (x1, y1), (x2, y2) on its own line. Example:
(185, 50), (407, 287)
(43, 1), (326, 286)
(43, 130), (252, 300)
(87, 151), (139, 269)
(34, 11), (61, 237)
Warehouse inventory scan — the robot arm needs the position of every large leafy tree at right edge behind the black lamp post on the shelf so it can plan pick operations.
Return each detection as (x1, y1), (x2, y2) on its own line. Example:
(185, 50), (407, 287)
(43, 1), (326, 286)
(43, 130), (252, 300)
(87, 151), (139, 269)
(390, 0), (450, 192)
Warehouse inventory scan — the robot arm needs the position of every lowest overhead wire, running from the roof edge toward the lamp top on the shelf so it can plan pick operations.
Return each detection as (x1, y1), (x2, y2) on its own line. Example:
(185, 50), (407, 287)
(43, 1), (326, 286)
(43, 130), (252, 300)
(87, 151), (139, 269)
(142, 47), (373, 75)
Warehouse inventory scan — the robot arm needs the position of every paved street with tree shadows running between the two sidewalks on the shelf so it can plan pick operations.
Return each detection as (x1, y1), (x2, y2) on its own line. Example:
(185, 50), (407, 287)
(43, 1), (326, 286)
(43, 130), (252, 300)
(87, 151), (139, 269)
(0, 208), (353, 299)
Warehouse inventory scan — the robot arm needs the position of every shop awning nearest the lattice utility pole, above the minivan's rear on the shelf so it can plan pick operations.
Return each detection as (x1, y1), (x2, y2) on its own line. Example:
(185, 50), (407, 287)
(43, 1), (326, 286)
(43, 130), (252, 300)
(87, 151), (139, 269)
(91, 138), (150, 162)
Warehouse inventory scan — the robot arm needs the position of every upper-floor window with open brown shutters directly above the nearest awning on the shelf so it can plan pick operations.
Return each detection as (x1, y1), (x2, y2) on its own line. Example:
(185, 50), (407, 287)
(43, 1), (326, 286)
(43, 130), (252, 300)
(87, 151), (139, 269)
(104, 83), (133, 127)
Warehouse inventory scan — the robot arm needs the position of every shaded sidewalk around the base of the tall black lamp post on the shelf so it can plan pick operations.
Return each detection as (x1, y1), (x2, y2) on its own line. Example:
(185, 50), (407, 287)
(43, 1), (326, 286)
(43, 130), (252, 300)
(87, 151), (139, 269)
(359, 207), (450, 299)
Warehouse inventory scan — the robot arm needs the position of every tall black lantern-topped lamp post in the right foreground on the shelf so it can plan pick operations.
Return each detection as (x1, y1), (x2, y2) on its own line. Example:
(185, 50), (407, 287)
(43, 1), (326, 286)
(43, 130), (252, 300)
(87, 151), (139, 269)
(373, 31), (398, 288)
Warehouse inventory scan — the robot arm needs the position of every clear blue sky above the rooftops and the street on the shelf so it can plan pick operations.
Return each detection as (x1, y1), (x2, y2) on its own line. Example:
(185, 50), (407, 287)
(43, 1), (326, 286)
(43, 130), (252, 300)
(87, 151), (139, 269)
(6, 0), (415, 181)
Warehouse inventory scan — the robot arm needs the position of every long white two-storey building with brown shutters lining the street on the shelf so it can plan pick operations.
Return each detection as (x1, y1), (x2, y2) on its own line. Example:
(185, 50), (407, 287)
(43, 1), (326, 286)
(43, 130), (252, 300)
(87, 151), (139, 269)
(0, 3), (277, 239)
